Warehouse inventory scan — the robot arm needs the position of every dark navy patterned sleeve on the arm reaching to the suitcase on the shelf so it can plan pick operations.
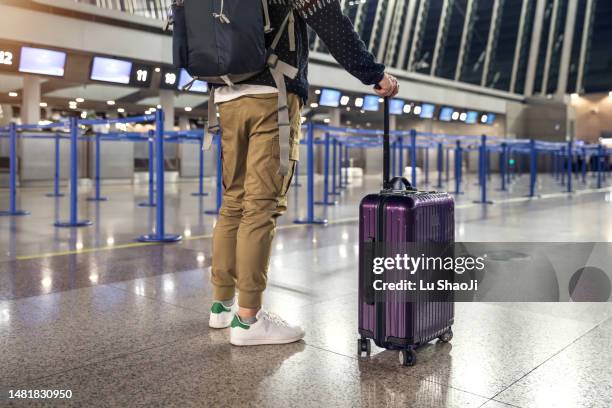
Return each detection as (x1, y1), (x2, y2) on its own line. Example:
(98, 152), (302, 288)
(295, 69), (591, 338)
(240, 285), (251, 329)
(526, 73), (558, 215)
(294, 0), (385, 85)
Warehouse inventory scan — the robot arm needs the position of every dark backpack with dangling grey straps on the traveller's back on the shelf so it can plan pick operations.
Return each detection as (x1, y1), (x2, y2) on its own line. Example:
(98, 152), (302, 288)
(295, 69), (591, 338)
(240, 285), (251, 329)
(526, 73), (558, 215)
(169, 0), (297, 175)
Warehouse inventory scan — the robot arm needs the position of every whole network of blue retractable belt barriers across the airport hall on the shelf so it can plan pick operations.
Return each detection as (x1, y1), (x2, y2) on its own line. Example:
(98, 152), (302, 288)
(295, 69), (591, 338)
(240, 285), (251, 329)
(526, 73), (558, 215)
(0, 117), (610, 230)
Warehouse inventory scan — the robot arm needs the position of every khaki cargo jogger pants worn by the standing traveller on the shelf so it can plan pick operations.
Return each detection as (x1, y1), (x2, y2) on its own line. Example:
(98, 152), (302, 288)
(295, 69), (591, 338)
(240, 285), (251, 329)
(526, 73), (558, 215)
(211, 94), (301, 309)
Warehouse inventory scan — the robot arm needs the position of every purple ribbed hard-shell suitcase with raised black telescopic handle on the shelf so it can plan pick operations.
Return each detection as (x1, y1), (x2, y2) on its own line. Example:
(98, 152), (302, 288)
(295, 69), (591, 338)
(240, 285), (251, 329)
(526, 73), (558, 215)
(358, 100), (455, 365)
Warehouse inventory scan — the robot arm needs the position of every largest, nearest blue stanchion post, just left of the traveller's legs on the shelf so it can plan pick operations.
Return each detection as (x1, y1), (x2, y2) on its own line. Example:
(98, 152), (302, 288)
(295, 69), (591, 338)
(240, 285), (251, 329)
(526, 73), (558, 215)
(138, 109), (183, 242)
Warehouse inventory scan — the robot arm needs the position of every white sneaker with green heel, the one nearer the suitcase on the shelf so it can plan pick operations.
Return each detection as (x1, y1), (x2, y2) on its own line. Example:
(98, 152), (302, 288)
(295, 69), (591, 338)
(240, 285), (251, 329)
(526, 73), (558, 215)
(230, 309), (304, 346)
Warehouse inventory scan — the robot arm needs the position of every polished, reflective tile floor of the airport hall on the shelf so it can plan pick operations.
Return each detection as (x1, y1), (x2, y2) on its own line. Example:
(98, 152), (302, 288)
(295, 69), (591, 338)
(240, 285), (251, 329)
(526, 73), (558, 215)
(0, 173), (612, 408)
